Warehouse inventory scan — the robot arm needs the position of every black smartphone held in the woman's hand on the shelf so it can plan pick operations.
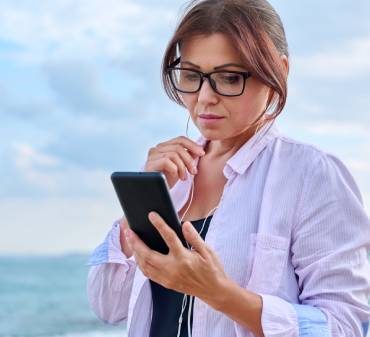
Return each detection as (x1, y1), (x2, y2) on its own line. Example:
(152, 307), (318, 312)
(111, 172), (186, 254)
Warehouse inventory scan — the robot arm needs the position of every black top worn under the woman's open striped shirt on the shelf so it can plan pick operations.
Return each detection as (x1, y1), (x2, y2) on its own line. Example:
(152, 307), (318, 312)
(149, 215), (212, 337)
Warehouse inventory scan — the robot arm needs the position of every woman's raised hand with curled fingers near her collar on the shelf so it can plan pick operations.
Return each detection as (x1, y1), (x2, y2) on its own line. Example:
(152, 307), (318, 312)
(144, 136), (205, 188)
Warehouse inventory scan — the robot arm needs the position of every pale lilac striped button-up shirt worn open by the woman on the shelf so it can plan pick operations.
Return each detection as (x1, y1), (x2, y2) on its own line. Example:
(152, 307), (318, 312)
(87, 125), (370, 337)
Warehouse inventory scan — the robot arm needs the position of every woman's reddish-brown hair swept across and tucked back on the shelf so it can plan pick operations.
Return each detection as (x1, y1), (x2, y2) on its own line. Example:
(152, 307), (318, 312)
(162, 0), (289, 118)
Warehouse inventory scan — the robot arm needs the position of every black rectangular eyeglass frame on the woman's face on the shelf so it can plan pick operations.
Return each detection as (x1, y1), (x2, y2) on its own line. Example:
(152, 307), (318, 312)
(167, 58), (252, 97)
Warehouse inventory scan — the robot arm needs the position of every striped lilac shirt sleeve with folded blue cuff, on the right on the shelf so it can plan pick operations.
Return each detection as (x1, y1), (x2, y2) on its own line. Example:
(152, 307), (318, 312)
(260, 155), (370, 337)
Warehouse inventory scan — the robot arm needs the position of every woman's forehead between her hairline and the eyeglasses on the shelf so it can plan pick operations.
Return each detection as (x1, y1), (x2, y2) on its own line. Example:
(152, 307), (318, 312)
(180, 33), (242, 68)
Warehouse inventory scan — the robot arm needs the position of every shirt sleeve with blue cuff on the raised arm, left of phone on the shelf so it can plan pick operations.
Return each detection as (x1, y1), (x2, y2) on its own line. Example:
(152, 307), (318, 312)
(87, 220), (136, 324)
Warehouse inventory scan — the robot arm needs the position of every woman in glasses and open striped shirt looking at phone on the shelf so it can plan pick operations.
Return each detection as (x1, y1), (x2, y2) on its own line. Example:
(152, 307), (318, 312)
(88, 0), (370, 337)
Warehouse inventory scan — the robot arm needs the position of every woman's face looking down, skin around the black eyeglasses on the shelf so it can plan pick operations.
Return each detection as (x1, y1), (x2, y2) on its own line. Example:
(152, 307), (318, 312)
(181, 33), (269, 140)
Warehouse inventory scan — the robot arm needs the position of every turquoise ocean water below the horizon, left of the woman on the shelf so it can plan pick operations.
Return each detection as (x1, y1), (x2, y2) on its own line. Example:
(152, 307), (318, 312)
(0, 255), (126, 337)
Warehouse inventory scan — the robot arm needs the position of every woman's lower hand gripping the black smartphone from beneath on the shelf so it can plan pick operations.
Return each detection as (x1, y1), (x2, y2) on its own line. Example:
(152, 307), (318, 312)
(125, 212), (228, 305)
